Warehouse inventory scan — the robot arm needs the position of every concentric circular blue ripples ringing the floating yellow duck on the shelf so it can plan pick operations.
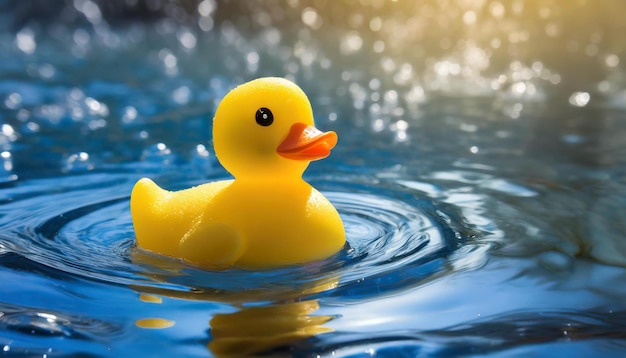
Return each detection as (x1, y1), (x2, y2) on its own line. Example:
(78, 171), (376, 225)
(0, 174), (482, 301)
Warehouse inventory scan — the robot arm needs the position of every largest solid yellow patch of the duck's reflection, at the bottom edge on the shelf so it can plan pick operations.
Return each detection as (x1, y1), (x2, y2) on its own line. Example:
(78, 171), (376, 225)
(208, 300), (332, 357)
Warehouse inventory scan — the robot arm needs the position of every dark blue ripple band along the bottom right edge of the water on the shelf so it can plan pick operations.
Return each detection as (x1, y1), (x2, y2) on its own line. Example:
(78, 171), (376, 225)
(303, 310), (626, 357)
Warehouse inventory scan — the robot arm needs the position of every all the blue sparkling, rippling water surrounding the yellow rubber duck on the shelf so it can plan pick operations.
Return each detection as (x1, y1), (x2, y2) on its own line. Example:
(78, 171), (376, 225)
(0, 0), (626, 357)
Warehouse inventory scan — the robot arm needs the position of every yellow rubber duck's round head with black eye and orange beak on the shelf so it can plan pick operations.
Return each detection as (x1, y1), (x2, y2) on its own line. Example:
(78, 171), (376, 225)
(213, 77), (337, 179)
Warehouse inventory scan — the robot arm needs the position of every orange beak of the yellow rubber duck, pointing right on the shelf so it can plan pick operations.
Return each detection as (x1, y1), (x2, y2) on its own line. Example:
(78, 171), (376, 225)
(276, 122), (337, 160)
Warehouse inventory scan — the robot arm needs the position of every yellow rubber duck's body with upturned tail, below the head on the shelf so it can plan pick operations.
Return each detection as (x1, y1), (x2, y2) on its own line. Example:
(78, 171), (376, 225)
(131, 179), (344, 268)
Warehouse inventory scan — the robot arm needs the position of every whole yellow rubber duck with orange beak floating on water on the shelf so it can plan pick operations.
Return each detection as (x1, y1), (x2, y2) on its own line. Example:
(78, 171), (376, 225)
(130, 77), (345, 269)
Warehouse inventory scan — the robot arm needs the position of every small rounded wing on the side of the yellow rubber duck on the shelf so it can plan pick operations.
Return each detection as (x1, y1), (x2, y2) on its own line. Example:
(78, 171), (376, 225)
(180, 223), (245, 267)
